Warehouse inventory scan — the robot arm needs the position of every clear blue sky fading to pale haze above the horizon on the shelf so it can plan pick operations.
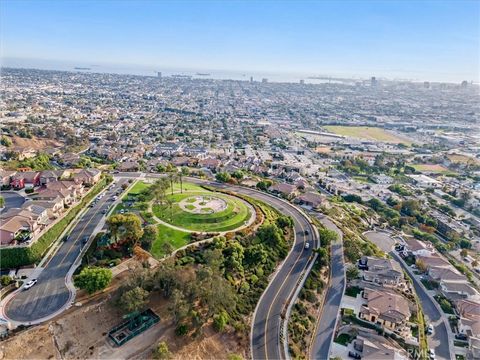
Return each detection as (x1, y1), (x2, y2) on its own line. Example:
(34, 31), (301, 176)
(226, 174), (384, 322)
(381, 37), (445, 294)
(0, 0), (480, 82)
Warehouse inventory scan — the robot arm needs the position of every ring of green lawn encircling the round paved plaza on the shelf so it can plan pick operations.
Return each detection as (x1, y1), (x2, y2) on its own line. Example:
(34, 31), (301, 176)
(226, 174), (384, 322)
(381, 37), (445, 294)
(153, 190), (250, 231)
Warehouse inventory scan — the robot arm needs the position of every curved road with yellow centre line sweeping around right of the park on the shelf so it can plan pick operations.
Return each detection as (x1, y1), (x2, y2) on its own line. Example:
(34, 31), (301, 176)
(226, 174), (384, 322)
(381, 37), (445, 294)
(116, 173), (318, 359)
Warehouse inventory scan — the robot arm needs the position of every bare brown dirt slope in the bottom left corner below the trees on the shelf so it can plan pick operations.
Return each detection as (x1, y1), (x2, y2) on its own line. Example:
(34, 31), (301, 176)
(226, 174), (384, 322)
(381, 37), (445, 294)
(0, 273), (248, 360)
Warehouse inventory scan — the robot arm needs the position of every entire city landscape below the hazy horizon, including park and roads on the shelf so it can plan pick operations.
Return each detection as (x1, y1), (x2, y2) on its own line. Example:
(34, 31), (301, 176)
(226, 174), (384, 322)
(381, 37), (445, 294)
(0, 68), (480, 360)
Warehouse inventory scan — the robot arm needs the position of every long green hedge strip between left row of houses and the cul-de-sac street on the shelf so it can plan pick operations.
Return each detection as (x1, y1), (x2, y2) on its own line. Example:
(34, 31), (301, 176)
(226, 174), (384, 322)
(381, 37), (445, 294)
(0, 178), (111, 269)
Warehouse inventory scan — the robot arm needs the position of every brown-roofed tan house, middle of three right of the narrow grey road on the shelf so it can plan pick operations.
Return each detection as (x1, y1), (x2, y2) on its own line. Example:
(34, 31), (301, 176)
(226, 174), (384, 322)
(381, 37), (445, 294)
(359, 288), (411, 334)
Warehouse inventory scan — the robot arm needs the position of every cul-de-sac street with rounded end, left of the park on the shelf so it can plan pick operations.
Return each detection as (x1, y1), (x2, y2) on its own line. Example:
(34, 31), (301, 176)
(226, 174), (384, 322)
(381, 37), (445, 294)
(4, 180), (127, 323)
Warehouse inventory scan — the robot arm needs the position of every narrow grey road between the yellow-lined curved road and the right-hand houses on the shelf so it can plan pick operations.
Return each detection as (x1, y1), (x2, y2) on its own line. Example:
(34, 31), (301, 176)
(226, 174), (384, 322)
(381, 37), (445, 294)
(310, 217), (345, 359)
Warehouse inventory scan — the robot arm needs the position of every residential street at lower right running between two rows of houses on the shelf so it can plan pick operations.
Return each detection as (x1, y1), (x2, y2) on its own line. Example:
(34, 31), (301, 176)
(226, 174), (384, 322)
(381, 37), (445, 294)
(390, 251), (453, 359)
